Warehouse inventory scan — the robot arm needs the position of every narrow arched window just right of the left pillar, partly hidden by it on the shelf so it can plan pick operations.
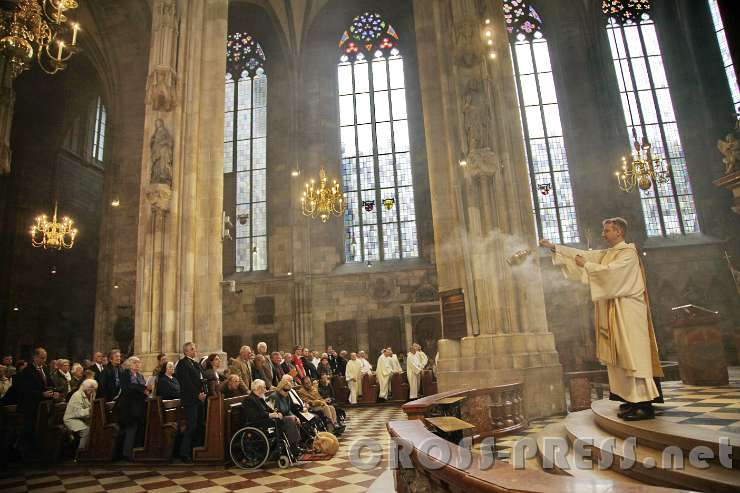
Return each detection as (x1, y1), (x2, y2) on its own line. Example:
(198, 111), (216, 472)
(224, 33), (267, 272)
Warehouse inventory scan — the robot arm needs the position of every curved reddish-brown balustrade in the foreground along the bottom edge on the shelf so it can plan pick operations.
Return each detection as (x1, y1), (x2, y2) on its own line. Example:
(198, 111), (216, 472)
(387, 420), (687, 493)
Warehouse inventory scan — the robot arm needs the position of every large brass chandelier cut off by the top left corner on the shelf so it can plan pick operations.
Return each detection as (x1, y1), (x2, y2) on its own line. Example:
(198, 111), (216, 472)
(0, 0), (80, 79)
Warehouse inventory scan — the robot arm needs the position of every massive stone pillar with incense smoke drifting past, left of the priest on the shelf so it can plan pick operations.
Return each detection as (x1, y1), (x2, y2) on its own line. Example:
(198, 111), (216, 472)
(414, 0), (565, 418)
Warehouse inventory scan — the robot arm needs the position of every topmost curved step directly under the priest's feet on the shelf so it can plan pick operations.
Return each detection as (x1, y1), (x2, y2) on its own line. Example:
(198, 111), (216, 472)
(591, 399), (740, 468)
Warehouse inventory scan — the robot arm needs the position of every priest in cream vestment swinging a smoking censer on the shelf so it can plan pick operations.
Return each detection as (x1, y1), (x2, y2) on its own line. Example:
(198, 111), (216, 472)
(540, 217), (663, 421)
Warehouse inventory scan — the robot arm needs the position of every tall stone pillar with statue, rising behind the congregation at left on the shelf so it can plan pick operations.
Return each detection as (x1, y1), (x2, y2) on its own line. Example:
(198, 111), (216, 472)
(134, 0), (227, 368)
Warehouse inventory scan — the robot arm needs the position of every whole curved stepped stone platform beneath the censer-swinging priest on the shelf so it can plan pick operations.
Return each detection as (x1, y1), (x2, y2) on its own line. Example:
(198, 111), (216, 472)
(536, 400), (740, 493)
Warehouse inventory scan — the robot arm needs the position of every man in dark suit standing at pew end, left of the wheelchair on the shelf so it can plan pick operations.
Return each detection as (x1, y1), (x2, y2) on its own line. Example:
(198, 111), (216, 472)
(175, 342), (206, 464)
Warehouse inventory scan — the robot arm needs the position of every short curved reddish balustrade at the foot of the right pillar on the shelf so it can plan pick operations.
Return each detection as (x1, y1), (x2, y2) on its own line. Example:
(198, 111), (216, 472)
(401, 383), (527, 441)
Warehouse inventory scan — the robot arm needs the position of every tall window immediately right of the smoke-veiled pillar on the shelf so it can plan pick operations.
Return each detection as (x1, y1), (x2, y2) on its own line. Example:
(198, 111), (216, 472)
(504, 0), (580, 243)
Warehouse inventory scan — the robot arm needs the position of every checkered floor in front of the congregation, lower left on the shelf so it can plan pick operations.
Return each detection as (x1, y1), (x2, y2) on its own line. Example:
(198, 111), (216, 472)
(0, 406), (406, 493)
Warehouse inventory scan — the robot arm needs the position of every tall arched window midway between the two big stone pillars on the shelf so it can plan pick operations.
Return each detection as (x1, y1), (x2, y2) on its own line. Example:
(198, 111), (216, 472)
(337, 13), (419, 262)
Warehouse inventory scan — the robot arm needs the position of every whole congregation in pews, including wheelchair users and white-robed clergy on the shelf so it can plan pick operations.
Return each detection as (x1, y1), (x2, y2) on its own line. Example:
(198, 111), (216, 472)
(0, 342), (436, 469)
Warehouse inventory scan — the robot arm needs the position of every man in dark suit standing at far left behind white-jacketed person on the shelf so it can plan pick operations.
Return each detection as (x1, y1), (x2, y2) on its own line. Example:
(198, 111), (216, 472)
(13, 347), (59, 456)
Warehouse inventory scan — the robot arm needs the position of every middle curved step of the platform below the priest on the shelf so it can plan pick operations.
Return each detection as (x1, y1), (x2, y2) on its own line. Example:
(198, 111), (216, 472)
(564, 410), (740, 493)
